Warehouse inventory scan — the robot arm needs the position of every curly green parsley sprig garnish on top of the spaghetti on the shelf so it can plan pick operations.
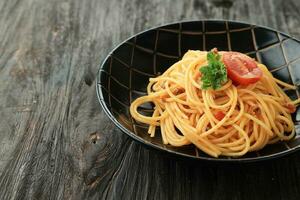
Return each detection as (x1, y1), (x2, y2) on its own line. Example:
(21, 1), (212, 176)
(200, 49), (227, 90)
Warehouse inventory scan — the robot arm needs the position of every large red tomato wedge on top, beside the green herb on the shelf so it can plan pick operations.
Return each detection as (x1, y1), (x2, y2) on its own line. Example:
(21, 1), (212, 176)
(223, 51), (263, 85)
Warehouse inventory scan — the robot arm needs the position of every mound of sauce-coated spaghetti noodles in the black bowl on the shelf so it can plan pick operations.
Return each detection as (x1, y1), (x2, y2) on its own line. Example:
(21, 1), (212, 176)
(130, 50), (300, 157)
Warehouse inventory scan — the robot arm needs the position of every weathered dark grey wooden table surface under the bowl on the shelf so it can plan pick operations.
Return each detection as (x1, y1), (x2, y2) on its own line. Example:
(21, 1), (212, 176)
(0, 0), (300, 200)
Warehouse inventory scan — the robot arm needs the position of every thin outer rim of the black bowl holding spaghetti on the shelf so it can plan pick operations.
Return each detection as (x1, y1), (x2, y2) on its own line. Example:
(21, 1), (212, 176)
(96, 19), (300, 163)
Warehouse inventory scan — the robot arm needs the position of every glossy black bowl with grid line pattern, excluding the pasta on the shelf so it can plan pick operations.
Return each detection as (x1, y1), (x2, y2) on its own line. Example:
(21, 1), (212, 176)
(97, 20), (300, 161)
